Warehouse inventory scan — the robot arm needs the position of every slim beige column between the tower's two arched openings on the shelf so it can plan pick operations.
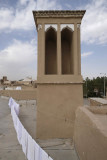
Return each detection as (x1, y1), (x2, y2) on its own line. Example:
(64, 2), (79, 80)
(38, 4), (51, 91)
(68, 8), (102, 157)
(57, 23), (62, 75)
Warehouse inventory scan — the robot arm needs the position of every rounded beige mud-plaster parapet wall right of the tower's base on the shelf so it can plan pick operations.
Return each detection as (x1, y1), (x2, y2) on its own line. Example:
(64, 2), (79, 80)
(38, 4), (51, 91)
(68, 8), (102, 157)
(74, 107), (107, 160)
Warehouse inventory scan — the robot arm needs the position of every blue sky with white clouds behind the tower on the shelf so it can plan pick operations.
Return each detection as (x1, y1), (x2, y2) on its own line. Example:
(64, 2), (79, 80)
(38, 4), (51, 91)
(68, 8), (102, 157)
(0, 0), (107, 80)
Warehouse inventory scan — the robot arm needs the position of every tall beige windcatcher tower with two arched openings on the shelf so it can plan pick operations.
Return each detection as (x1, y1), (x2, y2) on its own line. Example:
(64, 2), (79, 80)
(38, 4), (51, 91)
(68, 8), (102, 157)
(33, 10), (85, 139)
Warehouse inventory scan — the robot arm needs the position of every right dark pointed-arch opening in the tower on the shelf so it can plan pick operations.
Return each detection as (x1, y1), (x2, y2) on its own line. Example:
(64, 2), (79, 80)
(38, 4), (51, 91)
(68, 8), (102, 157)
(61, 26), (73, 74)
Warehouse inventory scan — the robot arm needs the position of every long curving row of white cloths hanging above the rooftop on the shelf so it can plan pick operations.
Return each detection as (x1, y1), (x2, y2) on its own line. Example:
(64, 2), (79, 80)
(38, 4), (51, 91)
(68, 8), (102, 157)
(8, 98), (53, 160)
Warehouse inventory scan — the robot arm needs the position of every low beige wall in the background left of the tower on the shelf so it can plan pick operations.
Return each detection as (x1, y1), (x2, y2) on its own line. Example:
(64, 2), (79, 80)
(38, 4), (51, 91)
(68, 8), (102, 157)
(0, 89), (36, 100)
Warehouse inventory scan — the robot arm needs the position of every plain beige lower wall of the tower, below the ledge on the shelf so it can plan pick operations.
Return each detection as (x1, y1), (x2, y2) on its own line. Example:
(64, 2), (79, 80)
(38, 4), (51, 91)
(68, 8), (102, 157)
(36, 84), (83, 139)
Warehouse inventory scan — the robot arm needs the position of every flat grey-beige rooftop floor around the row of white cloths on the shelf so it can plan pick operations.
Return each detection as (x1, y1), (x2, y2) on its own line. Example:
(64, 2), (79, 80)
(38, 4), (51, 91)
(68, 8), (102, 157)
(0, 98), (79, 160)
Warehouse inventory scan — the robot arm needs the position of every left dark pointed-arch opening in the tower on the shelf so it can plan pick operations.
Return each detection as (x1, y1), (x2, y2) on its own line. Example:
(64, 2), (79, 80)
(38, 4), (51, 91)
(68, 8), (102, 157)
(45, 26), (57, 74)
